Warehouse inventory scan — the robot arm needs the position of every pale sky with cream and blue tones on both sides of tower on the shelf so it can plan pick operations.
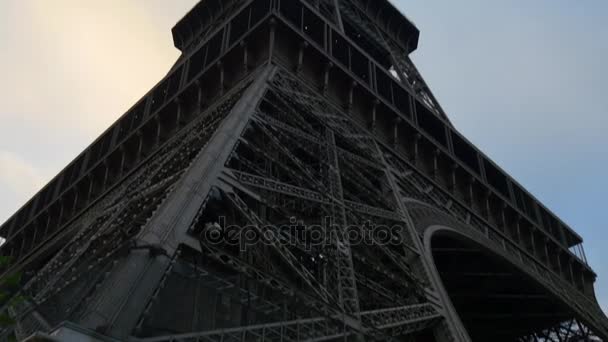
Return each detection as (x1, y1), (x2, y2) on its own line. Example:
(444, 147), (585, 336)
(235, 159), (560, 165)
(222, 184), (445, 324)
(0, 0), (608, 311)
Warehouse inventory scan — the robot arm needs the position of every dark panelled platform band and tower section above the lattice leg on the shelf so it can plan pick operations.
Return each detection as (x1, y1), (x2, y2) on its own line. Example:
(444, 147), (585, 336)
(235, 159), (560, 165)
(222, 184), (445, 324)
(0, 0), (595, 302)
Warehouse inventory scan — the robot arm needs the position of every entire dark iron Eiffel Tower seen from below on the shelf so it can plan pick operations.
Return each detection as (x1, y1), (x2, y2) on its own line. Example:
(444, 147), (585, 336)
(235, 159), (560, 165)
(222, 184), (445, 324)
(0, 0), (608, 342)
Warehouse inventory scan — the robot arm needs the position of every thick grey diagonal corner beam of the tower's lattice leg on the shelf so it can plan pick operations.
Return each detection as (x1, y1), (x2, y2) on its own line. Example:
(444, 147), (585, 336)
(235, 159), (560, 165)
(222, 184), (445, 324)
(80, 66), (274, 339)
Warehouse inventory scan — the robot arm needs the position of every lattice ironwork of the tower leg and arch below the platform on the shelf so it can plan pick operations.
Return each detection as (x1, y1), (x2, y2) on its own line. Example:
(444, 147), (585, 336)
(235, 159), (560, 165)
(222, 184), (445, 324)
(1, 1), (602, 341)
